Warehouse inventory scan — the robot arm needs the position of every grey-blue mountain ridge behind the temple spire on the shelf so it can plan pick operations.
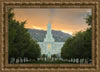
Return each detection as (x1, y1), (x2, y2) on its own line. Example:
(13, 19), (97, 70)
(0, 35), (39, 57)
(27, 29), (72, 42)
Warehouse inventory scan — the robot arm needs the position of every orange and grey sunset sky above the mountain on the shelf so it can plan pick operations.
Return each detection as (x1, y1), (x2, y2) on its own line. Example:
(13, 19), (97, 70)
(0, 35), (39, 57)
(13, 8), (91, 35)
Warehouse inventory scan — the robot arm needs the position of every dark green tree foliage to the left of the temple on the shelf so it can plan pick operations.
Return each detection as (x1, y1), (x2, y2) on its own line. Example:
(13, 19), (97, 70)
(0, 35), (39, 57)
(8, 8), (41, 62)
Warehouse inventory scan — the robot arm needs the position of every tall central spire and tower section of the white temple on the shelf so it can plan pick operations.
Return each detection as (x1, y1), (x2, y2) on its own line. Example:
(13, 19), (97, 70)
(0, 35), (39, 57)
(44, 12), (54, 59)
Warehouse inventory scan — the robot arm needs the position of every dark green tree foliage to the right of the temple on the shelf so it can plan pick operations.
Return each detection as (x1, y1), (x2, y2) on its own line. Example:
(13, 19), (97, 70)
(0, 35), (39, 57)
(61, 15), (92, 59)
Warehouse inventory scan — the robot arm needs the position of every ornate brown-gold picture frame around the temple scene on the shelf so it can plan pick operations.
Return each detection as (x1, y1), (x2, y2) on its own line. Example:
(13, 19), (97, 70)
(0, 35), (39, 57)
(0, 0), (100, 72)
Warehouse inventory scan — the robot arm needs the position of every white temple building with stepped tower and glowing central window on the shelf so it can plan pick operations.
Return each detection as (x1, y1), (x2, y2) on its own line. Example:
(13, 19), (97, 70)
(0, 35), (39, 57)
(38, 22), (64, 58)
